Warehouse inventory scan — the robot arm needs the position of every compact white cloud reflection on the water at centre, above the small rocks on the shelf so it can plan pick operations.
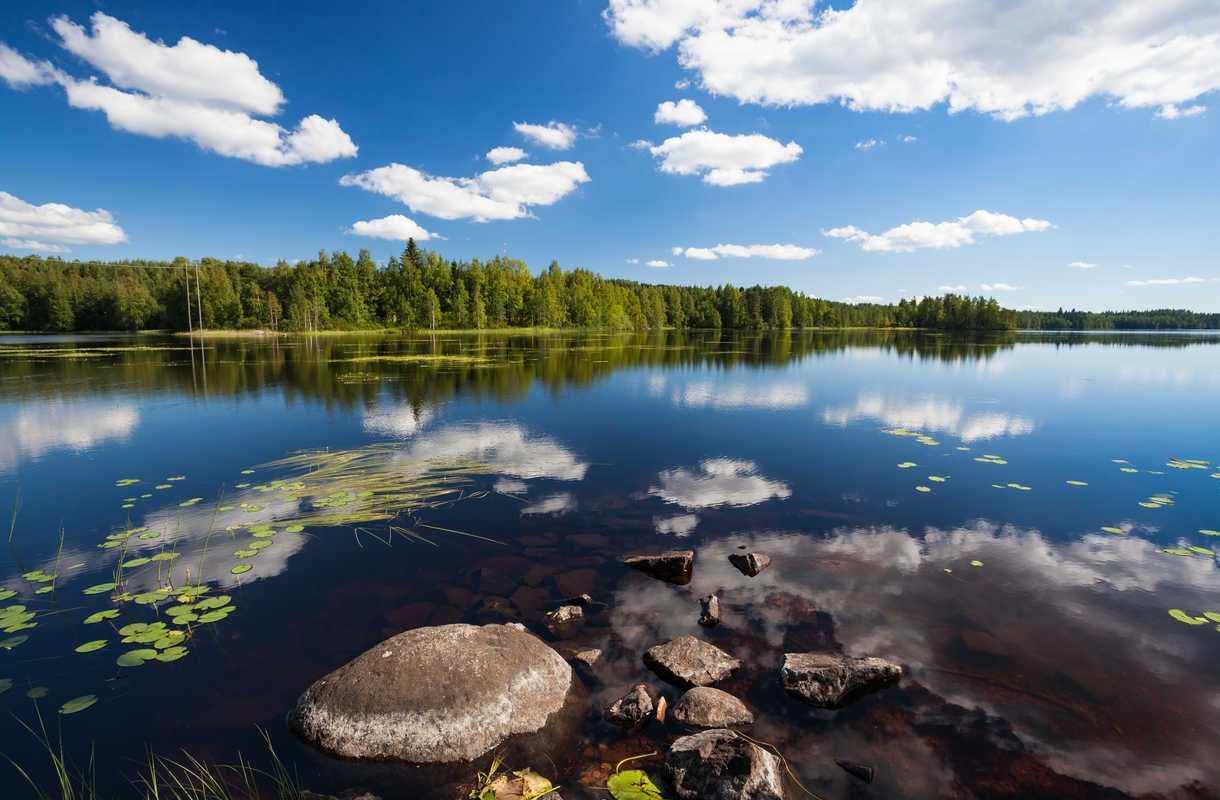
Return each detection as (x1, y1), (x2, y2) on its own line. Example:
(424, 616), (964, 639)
(648, 459), (792, 509)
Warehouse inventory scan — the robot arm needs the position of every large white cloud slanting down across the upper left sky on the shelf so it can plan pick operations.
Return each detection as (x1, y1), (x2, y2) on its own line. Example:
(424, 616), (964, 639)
(0, 11), (356, 167)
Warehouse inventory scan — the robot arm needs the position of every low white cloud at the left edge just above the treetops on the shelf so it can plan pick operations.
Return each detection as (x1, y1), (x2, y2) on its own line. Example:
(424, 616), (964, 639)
(0, 191), (127, 252)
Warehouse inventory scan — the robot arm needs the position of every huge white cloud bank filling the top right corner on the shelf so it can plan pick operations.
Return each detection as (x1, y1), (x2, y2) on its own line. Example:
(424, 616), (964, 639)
(604, 0), (1220, 120)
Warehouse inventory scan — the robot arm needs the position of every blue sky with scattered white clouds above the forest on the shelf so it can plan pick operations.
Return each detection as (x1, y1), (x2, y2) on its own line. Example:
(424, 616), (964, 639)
(0, 0), (1220, 311)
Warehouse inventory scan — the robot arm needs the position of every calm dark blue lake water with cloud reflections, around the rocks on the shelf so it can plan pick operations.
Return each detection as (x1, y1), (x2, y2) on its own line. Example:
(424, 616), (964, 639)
(0, 332), (1220, 800)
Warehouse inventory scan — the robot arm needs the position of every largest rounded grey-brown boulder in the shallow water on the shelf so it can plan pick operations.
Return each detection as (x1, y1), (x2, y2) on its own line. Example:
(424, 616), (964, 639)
(289, 624), (572, 763)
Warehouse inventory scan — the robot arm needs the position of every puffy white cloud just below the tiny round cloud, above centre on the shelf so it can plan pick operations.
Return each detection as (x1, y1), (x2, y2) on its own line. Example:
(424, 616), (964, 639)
(648, 128), (803, 187)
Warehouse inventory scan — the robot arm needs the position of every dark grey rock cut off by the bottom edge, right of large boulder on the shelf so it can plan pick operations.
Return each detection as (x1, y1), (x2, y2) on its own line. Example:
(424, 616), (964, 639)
(665, 728), (787, 800)
